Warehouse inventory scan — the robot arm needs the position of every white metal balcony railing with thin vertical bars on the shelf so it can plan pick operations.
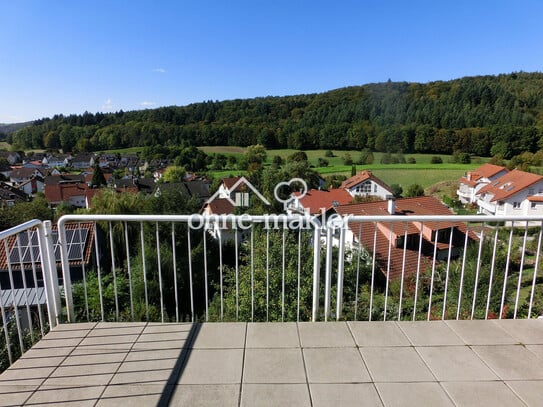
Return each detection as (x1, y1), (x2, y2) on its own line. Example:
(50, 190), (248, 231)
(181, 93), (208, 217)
(0, 215), (543, 372)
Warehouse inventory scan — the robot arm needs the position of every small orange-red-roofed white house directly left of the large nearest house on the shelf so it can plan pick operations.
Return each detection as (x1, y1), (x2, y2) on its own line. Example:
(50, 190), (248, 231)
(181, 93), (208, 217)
(287, 188), (353, 216)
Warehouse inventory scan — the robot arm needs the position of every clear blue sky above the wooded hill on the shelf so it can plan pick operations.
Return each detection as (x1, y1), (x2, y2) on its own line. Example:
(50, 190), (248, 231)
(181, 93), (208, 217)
(0, 0), (543, 123)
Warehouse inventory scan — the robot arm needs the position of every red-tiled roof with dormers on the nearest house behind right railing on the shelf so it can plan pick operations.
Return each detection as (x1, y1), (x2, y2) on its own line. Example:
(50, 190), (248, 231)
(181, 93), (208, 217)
(336, 196), (477, 279)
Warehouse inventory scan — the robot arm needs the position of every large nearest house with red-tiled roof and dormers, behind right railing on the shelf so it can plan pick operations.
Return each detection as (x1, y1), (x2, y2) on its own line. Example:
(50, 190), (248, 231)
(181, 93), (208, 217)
(334, 196), (477, 280)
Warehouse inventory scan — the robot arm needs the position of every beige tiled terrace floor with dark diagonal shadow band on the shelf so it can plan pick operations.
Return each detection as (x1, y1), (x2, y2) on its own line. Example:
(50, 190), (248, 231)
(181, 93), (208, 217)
(0, 320), (543, 407)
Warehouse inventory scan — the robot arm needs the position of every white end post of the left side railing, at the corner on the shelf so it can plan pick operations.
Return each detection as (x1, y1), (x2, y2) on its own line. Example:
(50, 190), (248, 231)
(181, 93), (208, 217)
(38, 220), (62, 329)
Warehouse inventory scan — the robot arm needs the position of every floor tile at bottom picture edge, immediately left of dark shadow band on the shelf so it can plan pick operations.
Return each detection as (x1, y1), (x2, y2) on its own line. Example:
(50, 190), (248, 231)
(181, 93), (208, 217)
(96, 384), (168, 407)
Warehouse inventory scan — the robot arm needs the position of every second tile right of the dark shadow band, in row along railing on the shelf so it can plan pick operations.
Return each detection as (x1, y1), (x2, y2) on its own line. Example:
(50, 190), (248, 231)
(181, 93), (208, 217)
(247, 322), (300, 348)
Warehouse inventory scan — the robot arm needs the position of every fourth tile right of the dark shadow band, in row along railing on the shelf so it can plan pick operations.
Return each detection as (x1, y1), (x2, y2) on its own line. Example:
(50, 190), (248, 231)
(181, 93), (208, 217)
(347, 321), (410, 346)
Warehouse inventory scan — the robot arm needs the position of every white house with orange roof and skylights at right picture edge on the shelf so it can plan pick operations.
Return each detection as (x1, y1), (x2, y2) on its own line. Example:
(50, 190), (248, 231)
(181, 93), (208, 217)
(477, 170), (543, 216)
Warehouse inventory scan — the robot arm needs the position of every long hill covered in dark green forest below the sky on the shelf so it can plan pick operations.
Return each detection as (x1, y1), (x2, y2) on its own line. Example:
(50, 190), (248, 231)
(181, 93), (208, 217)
(10, 72), (543, 158)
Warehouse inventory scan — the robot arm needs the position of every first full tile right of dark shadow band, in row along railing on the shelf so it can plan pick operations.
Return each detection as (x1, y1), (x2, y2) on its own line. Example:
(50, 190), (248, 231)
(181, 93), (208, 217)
(192, 322), (247, 349)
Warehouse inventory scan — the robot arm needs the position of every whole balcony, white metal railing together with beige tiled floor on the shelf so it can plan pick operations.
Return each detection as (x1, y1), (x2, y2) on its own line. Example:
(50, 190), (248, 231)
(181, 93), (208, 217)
(0, 215), (543, 406)
